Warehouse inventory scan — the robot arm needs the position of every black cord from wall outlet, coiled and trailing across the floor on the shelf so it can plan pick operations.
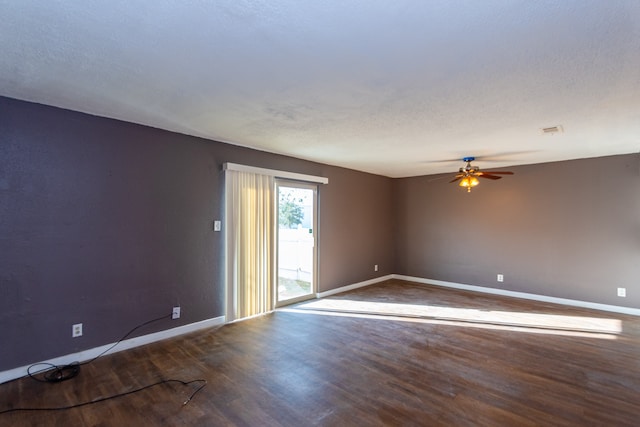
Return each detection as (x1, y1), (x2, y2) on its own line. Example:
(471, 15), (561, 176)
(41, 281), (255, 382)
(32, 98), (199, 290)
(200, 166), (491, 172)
(0, 314), (207, 415)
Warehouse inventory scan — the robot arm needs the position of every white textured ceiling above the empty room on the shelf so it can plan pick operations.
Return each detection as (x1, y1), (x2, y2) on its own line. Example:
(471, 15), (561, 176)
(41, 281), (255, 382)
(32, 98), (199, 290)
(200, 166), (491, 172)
(0, 0), (640, 177)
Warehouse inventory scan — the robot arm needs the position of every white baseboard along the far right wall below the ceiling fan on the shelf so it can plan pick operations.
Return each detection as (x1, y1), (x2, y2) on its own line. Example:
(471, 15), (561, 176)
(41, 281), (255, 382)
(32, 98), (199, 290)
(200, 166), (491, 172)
(392, 274), (640, 316)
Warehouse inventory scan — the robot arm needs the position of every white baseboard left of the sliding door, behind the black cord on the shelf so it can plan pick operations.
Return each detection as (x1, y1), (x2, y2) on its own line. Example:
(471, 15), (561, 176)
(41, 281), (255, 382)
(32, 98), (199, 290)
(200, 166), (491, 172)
(0, 316), (225, 384)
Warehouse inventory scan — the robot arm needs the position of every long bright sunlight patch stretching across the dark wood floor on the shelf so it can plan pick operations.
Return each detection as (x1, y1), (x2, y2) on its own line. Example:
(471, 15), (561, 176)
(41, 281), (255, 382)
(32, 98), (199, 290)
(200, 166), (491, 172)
(281, 299), (622, 339)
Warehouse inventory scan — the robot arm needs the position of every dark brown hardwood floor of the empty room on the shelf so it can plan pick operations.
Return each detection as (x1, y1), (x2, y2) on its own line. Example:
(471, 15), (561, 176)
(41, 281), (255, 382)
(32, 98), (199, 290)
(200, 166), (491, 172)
(0, 281), (640, 427)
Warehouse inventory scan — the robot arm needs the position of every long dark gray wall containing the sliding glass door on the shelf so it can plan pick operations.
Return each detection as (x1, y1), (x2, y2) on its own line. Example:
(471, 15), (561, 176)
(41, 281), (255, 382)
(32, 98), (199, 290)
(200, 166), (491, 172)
(0, 97), (393, 370)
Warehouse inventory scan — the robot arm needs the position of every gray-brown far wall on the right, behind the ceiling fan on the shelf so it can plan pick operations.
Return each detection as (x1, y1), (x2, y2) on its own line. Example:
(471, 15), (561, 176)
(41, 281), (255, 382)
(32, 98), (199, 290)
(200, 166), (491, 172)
(393, 154), (640, 308)
